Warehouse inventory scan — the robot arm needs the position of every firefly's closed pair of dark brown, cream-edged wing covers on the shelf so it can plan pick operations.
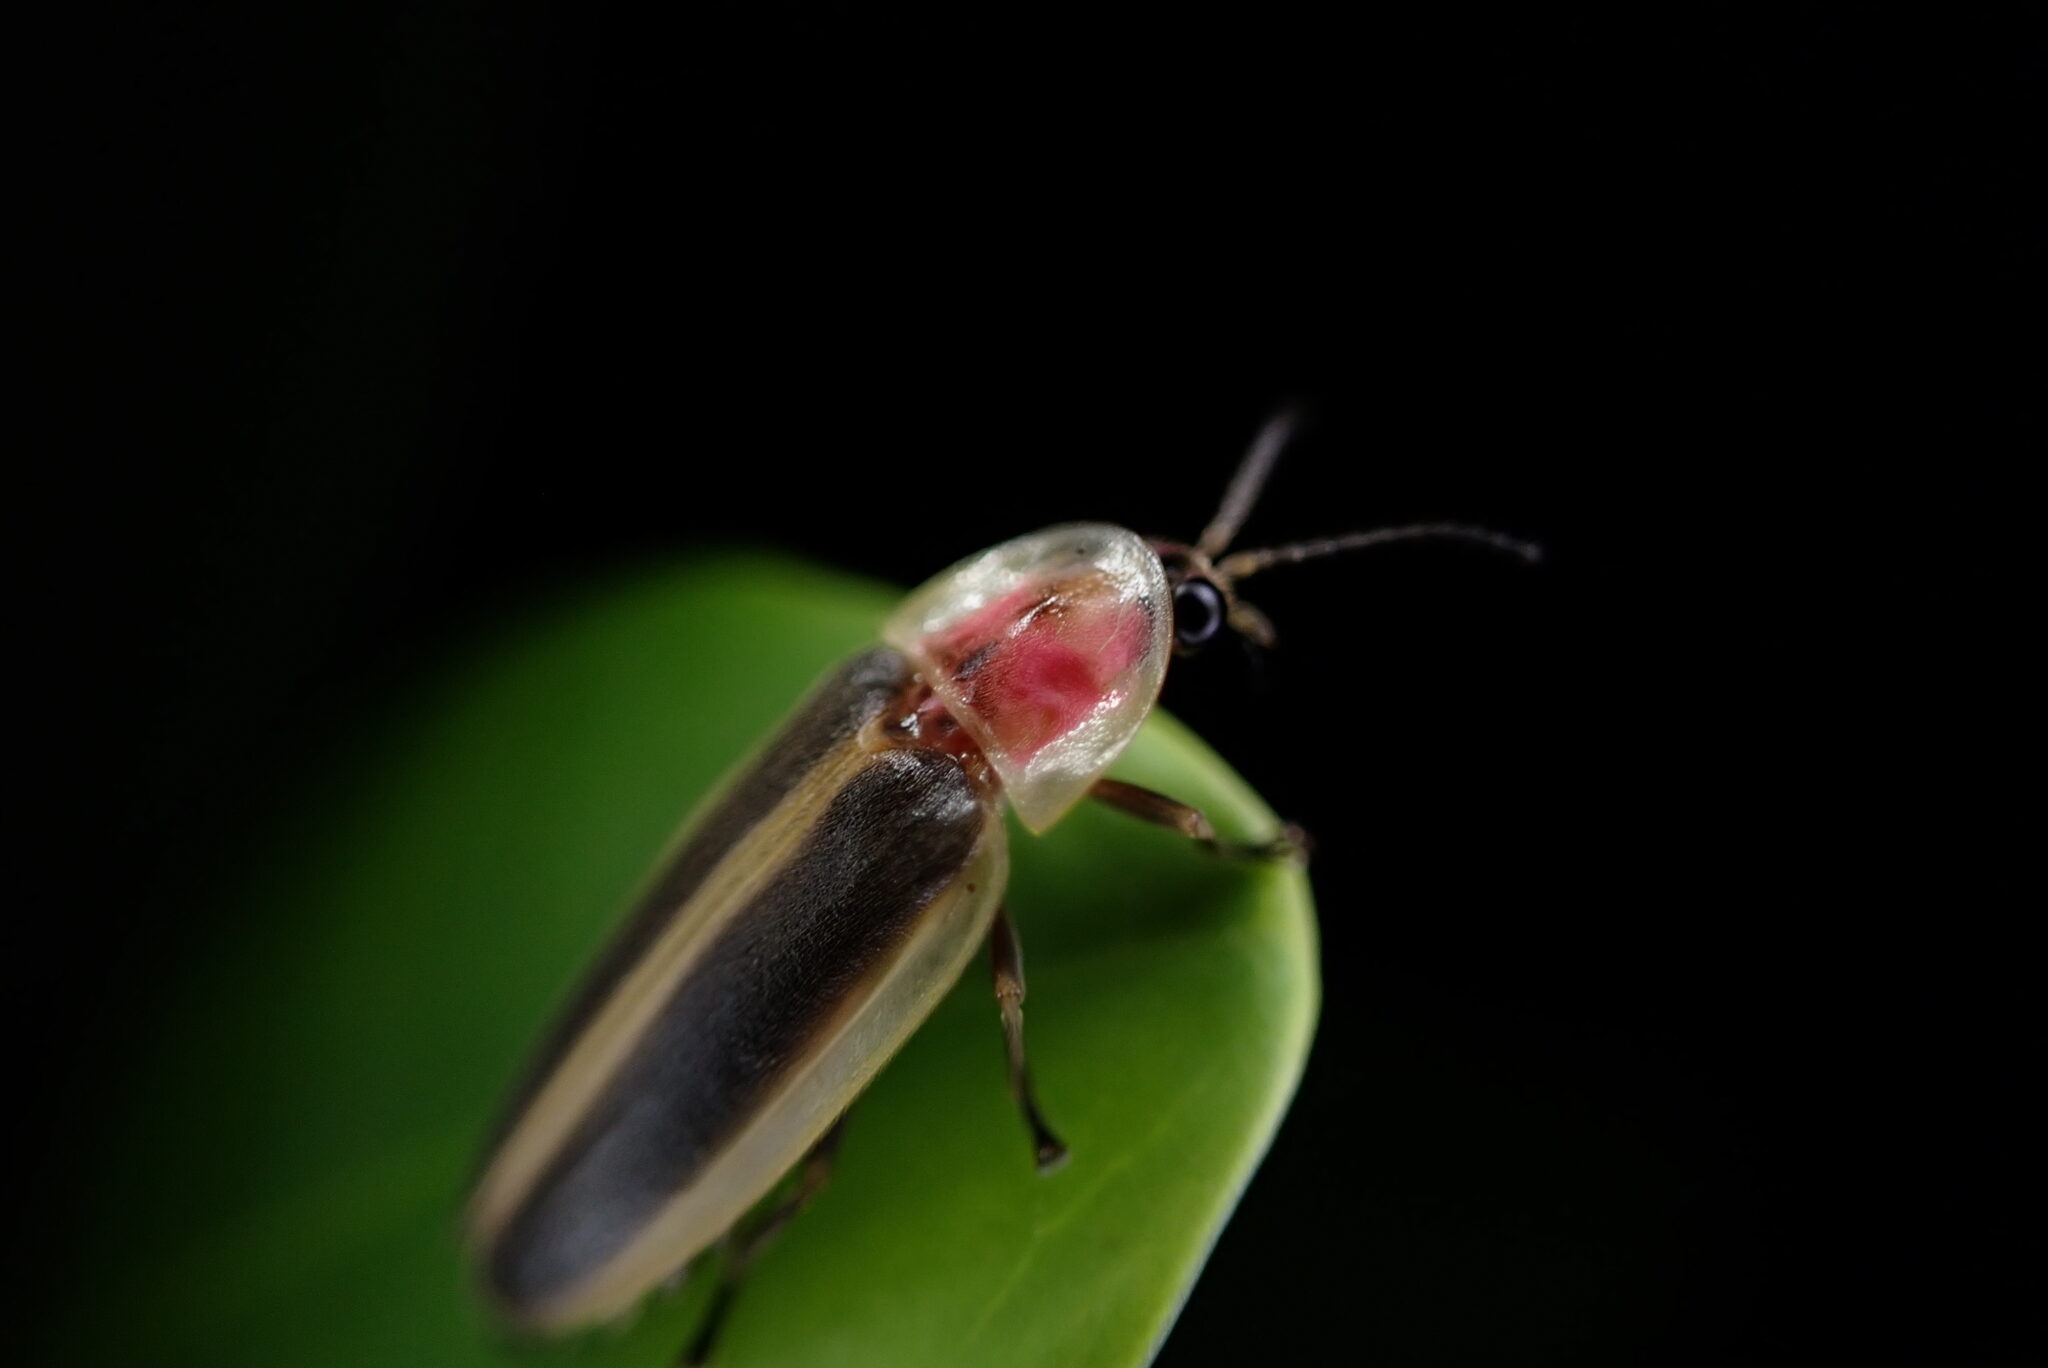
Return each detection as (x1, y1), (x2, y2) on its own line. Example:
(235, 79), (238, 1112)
(471, 649), (1006, 1329)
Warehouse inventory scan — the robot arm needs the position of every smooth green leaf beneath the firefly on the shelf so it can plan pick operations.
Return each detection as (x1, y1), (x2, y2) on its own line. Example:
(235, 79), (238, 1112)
(56, 557), (1317, 1368)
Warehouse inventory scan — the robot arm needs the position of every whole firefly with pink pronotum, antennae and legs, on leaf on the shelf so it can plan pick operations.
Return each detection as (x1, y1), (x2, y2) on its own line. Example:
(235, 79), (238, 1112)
(467, 414), (1536, 1362)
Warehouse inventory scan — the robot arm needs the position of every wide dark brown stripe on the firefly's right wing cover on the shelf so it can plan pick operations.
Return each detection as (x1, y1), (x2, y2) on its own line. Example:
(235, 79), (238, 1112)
(489, 750), (993, 1307)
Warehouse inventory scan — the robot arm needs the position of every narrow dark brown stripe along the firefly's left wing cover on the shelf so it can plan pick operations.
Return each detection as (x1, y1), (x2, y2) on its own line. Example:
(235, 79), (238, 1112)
(485, 647), (911, 1153)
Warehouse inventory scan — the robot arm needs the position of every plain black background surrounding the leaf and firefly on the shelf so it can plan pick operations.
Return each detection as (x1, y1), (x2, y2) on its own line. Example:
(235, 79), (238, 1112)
(24, 0), (2044, 1368)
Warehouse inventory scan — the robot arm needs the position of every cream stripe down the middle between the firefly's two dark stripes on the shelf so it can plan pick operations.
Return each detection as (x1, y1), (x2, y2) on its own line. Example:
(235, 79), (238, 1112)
(471, 737), (872, 1243)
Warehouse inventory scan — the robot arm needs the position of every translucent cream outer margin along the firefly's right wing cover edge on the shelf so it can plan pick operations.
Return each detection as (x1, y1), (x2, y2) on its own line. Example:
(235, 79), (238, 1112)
(528, 809), (1010, 1329)
